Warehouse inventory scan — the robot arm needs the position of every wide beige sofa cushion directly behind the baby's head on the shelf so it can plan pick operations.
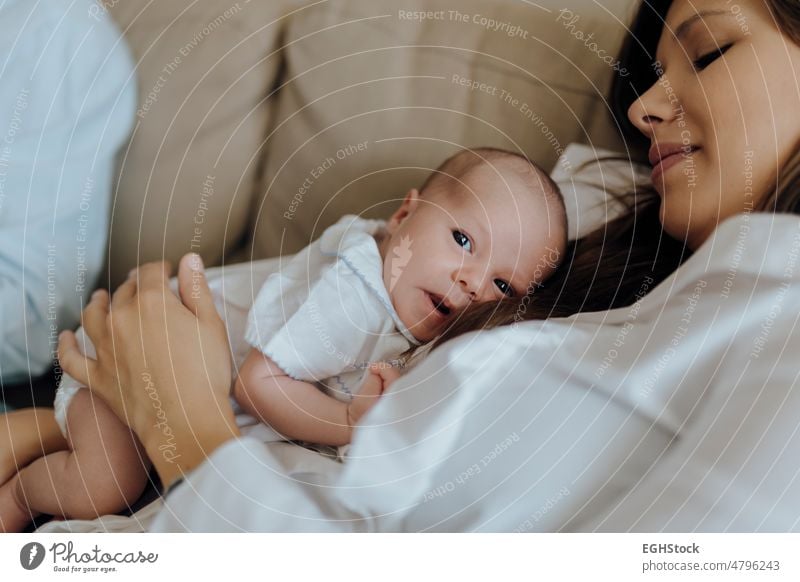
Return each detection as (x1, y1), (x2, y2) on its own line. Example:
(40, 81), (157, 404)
(247, 0), (633, 257)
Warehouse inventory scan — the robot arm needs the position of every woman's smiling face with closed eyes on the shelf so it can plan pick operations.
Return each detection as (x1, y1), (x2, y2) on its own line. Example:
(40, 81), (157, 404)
(628, 0), (800, 249)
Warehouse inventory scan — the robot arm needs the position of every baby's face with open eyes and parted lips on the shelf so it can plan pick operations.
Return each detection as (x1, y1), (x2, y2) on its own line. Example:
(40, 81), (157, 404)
(380, 166), (564, 342)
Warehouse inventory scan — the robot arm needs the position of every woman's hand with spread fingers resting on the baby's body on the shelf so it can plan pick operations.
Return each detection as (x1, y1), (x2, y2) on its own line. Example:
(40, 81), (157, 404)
(58, 254), (238, 486)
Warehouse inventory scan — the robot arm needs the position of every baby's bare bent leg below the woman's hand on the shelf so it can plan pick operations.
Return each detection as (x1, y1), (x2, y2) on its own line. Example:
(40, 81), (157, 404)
(10, 389), (149, 519)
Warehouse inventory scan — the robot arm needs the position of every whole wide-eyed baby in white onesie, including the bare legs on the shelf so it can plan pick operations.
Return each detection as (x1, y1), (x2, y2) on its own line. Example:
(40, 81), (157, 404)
(0, 148), (567, 530)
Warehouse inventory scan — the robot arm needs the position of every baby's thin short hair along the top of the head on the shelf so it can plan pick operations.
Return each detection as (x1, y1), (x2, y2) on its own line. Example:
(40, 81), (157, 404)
(420, 147), (567, 233)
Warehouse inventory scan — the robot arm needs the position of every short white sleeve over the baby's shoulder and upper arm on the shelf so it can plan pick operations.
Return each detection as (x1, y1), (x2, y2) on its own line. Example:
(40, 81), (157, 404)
(245, 261), (385, 382)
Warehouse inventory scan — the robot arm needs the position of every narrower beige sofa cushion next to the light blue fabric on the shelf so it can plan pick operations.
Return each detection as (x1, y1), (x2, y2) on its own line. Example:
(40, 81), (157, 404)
(103, 0), (308, 286)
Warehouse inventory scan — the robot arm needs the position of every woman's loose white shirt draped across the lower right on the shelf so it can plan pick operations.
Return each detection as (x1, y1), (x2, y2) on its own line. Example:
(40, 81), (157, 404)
(42, 146), (800, 531)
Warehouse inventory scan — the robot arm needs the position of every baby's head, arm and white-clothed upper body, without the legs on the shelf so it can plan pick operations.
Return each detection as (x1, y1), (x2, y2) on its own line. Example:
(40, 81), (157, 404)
(233, 148), (566, 445)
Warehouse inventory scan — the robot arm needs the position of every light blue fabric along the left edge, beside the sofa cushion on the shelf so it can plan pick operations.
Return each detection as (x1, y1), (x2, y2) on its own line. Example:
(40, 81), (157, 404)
(0, 0), (136, 383)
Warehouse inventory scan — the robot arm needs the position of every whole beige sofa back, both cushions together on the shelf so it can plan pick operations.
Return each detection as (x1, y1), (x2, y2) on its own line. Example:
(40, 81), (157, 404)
(103, 0), (634, 285)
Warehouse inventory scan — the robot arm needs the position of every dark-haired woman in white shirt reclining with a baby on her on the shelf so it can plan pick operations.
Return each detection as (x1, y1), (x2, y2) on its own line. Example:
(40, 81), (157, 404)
(14, 0), (800, 531)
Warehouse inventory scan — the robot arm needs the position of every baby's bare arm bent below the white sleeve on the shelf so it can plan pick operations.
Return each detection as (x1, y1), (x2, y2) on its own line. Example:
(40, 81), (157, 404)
(233, 348), (384, 446)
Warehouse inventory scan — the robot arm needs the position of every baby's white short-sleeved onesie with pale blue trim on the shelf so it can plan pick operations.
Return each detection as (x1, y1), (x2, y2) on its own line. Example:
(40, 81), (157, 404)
(55, 215), (420, 456)
